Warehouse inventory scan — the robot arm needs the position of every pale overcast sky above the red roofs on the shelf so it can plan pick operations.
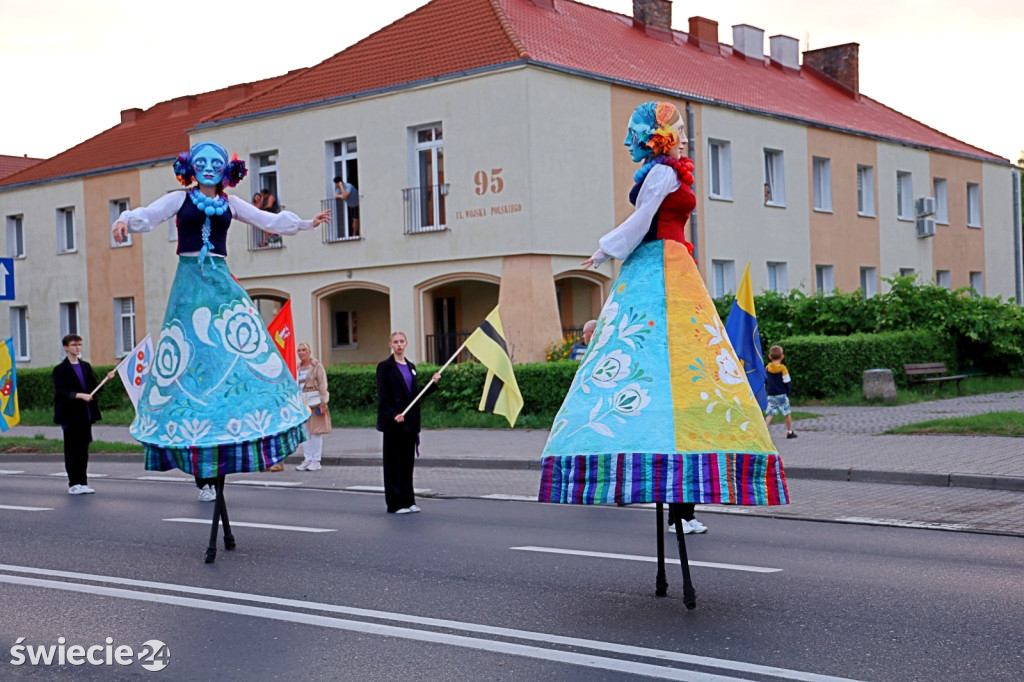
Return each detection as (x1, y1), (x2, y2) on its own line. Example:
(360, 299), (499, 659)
(0, 0), (1024, 162)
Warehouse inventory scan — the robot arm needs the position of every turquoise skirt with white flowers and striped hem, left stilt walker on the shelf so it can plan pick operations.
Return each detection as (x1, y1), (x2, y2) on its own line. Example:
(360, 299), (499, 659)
(131, 256), (309, 478)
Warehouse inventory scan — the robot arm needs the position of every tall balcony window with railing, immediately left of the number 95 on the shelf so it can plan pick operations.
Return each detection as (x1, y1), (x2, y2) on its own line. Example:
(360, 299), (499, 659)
(401, 123), (447, 235)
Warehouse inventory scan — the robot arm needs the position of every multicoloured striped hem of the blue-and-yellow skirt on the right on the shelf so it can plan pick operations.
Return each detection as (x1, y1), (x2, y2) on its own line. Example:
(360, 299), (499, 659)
(538, 453), (790, 505)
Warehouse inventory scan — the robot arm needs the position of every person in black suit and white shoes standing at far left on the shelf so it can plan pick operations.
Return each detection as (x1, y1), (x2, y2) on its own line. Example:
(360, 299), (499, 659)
(52, 334), (106, 495)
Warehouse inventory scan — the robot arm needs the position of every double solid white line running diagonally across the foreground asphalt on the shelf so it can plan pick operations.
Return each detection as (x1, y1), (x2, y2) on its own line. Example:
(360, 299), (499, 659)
(0, 564), (864, 682)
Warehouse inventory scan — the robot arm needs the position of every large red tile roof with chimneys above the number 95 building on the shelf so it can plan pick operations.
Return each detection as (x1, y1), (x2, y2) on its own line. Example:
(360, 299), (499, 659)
(206, 0), (1005, 161)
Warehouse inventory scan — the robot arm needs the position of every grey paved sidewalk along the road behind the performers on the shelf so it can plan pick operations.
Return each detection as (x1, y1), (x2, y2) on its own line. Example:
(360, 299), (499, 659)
(8, 392), (1024, 536)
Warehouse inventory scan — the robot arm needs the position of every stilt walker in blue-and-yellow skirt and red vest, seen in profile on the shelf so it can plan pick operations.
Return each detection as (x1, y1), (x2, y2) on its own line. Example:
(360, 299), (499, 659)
(539, 102), (788, 608)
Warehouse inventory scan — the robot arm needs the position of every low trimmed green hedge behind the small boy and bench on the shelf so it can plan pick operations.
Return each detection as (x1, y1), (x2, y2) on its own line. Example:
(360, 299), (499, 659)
(778, 331), (956, 399)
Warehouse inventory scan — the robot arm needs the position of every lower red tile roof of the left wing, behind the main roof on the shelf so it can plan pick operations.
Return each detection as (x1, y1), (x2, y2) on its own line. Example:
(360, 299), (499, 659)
(0, 72), (299, 188)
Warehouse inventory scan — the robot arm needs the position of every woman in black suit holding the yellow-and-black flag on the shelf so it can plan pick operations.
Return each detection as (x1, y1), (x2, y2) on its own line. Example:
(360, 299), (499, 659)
(377, 332), (441, 514)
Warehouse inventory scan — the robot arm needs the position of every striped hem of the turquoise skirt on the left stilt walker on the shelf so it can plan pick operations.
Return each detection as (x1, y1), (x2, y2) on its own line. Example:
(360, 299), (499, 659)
(142, 424), (306, 478)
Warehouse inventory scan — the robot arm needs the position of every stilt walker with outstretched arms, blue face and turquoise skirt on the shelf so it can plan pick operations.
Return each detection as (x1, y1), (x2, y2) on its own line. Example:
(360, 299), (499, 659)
(112, 142), (330, 563)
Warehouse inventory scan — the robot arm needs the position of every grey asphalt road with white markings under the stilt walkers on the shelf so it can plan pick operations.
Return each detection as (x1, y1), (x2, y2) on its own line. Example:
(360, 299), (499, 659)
(0, 476), (1024, 682)
